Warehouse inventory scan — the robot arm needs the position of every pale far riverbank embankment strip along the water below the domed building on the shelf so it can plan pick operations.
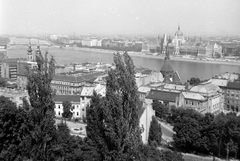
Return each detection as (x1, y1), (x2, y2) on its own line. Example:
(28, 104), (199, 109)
(63, 47), (240, 66)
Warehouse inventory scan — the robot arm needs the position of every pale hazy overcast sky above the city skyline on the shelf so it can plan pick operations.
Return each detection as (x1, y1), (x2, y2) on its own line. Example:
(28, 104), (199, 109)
(0, 0), (240, 35)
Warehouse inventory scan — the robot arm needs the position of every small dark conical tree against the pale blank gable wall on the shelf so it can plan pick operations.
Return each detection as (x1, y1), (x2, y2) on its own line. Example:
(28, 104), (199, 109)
(148, 116), (162, 146)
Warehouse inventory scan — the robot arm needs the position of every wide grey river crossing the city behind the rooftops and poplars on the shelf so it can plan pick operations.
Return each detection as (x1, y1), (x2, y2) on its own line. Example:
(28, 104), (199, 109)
(8, 46), (240, 82)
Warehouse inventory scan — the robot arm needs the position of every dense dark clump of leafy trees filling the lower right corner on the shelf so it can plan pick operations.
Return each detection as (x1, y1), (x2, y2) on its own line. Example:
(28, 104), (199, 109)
(173, 109), (240, 158)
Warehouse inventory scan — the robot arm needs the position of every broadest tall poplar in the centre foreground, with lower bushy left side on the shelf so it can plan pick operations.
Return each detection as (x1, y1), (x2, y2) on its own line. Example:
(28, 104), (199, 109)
(86, 52), (142, 161)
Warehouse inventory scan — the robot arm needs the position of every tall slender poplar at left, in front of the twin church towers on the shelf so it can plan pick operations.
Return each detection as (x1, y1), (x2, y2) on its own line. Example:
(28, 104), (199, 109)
(25, 52), (56, 160)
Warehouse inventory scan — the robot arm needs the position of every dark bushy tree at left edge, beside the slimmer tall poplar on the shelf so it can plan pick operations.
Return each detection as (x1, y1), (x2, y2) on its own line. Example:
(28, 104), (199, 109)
(0, 96), (28, 160)
